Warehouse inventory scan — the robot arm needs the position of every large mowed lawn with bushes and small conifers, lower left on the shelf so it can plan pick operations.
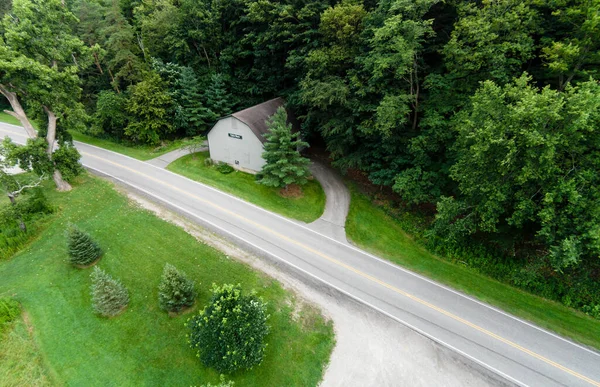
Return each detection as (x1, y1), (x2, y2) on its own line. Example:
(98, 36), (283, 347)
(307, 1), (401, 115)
(0, 176), (334, 386)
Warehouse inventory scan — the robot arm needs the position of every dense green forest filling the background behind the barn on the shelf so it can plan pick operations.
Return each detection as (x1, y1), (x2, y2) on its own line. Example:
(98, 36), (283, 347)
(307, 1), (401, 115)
(0, 0), (600, 318)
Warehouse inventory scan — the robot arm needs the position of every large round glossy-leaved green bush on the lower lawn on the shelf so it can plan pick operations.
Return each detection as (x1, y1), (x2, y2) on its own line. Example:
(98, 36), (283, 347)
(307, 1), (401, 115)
(187, 284), (269, 373)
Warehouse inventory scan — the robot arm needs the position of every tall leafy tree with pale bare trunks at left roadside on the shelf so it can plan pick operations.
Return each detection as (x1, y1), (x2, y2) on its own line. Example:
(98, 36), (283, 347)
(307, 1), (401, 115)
(0, 0), (91, 190)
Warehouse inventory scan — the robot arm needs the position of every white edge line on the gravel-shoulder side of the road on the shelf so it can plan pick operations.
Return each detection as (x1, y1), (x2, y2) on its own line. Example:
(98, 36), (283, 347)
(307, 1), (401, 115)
(87, 166), (528, 387)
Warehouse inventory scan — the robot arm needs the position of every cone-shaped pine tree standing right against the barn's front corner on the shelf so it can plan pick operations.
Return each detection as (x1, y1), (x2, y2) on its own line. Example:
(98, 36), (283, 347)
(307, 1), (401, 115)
(256, 107), (310, 192)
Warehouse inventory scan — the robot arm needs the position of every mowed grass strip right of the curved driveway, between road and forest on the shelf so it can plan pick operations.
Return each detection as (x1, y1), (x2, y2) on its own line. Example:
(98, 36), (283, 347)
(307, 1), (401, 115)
(346, 184), (600, 349)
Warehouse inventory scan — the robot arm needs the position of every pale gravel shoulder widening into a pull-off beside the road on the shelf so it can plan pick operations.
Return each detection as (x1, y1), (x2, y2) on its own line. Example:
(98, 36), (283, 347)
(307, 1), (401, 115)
(119, 187), (502, 387)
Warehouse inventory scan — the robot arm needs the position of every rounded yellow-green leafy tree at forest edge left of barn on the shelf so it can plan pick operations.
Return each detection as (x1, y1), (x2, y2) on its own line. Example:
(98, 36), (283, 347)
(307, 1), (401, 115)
(125, 72), (173, 144)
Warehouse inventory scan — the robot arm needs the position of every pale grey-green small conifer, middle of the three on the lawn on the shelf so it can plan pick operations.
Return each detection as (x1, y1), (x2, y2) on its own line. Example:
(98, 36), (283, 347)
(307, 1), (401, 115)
(90, 266), (129, 317)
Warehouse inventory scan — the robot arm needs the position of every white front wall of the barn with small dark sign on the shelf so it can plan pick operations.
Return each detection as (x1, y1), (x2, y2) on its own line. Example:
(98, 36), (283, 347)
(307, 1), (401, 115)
(208, 117), (265, 172)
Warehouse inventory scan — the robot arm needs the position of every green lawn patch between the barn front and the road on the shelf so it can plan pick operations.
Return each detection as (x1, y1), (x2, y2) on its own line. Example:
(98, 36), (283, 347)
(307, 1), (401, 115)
(167, 152), (325, 223)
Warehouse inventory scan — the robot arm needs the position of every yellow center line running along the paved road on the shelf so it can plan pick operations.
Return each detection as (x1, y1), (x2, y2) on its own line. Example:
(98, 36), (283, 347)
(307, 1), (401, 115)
(82, 152), (600, 387)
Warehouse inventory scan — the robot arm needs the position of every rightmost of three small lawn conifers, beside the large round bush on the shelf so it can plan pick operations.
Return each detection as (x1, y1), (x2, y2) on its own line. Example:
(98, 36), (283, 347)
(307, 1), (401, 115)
(158, 263), (196, 312)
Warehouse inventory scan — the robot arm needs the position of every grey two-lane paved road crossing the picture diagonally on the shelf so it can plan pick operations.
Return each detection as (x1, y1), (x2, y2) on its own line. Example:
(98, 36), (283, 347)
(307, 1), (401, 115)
(0, 124), (600, 387)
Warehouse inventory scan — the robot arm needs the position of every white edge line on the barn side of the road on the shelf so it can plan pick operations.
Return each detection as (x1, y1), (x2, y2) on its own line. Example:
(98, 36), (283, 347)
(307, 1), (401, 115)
(74, 136), (600, 357)
